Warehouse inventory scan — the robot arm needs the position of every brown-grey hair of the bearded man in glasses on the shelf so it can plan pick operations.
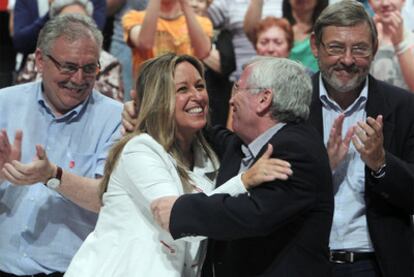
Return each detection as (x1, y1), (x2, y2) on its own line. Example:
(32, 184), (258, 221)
(313, 0), (378, 48)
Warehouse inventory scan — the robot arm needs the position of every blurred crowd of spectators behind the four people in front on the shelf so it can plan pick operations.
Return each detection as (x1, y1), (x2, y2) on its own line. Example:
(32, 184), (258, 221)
(0, 0), (414, 97)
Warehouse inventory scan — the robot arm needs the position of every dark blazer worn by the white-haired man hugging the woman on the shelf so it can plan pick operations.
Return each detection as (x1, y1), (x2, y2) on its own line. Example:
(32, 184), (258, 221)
(170, 123), (333, 277)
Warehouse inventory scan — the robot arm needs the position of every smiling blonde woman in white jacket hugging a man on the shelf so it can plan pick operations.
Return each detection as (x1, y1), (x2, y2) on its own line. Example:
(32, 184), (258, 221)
(65, 54), (288, 277)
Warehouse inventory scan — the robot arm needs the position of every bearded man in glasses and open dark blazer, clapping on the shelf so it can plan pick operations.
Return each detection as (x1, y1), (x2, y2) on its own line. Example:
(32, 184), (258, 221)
(310, 1), (414, 277)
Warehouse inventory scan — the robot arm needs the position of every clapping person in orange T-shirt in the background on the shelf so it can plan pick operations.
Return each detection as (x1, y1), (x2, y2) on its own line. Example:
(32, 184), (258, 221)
(122, 0), (213, 76)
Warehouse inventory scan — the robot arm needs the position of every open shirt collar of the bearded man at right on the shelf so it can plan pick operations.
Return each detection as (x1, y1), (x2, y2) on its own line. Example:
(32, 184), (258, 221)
(319, 74), (368, 116)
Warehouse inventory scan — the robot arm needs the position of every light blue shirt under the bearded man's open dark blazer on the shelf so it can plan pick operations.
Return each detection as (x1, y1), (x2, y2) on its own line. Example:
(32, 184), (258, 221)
(319, 77), (374, 252)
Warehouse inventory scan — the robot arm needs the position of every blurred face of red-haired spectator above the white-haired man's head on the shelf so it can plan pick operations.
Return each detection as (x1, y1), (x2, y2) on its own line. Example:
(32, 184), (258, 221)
(256, 26), (289, 58)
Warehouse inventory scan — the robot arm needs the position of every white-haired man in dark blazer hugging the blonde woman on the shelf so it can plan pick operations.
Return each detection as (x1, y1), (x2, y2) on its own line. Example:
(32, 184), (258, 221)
(152, 57), (333, 277)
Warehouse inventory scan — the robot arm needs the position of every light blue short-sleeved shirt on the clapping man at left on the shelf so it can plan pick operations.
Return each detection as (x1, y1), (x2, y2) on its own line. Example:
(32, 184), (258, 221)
(0, 82), (122, 275)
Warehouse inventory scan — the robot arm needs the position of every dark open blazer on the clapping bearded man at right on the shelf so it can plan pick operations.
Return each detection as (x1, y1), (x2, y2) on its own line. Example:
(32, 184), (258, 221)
(310, 74), (414, 277)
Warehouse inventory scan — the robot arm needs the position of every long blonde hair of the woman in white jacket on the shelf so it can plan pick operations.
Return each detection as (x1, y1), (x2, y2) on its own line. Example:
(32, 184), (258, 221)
(101, 53), (217, 197)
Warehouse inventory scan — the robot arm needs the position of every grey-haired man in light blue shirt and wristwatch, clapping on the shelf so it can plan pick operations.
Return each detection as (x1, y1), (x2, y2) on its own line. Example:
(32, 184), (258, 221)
(0, 14), (122, 276)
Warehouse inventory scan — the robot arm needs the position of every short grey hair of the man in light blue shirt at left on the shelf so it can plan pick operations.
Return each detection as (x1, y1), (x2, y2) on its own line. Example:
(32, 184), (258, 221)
(37, 13), (103, 54)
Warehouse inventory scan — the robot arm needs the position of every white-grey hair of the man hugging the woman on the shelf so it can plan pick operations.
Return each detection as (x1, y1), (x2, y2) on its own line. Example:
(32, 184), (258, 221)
(247, 57), (312, 123)
